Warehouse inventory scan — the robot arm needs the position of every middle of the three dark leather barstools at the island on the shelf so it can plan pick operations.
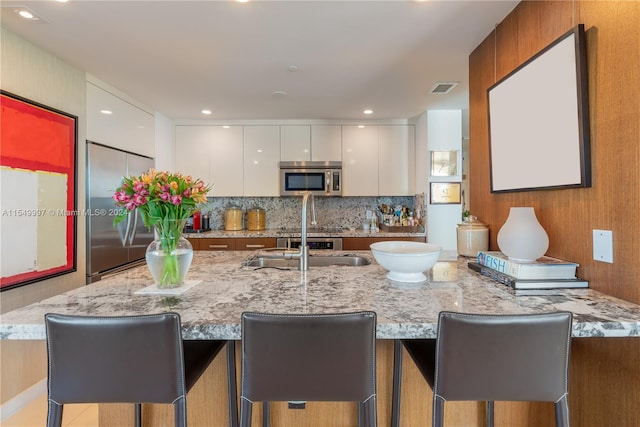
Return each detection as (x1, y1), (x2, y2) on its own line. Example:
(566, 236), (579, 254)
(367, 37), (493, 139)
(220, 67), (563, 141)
(240, 312), (377, 427)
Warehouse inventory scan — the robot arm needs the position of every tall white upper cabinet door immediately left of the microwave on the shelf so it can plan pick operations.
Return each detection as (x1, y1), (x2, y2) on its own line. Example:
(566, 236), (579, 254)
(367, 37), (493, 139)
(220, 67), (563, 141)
(244, 126), (280, 197)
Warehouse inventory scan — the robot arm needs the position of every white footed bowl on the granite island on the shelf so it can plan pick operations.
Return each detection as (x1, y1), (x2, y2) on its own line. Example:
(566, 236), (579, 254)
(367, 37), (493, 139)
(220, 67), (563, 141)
(369, 241), (442, 283)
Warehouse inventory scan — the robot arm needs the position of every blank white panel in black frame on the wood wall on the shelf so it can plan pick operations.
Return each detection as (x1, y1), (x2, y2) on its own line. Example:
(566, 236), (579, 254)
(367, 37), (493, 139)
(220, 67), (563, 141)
(487, 24), (591, 193)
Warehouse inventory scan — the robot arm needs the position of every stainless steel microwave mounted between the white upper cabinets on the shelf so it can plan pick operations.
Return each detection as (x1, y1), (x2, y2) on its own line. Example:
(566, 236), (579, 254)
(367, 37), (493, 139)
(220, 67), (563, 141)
(280, 162), (342, 196)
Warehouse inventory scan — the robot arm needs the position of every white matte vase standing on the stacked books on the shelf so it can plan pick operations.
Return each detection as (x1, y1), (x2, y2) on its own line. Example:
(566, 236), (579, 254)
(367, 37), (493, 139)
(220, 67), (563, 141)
(498, 207), (549, 262)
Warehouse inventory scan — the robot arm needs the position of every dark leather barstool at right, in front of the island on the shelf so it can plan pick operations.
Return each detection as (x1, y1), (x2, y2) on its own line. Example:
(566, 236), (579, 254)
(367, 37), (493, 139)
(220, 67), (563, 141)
(392, 312), (572, 427)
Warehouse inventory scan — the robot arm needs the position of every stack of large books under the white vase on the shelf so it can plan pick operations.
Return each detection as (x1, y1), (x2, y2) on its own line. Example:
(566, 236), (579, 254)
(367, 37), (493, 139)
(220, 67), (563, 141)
(468, 251), (589, 289)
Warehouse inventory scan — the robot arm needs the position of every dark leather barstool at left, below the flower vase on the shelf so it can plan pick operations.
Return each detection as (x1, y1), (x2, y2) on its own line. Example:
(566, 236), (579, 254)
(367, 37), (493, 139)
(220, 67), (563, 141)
(45, 313), (237, 427)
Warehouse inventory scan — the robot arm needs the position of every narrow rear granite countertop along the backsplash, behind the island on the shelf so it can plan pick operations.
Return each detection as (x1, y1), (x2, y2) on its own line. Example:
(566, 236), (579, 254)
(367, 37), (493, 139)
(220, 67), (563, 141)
(184, 227), (426, 239)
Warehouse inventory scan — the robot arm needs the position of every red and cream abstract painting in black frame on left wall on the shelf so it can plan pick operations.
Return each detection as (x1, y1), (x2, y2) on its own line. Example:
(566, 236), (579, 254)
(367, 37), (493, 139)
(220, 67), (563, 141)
(0, 91), (77, 291)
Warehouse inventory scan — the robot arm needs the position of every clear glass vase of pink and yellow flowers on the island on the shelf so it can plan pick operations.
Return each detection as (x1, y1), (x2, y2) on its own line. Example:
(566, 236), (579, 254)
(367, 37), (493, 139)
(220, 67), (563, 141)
(113, 169), (210, 289)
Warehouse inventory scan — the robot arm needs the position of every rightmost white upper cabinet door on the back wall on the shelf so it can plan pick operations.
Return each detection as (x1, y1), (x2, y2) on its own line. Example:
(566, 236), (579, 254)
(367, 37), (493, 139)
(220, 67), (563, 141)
(378, 125), (415, 196)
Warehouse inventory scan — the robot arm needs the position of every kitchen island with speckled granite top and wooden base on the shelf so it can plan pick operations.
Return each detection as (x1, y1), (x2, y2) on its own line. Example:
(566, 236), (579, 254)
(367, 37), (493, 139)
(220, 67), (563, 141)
(0, 251), (640, 426)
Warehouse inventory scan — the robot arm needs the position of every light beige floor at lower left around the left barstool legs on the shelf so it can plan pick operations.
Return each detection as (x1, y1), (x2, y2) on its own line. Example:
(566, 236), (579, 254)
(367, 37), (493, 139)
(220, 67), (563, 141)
(0, 394), (98, 427)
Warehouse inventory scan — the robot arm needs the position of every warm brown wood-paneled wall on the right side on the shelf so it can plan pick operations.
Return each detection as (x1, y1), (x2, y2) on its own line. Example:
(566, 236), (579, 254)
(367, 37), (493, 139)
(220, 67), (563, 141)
(469, 1), (640, 427)
